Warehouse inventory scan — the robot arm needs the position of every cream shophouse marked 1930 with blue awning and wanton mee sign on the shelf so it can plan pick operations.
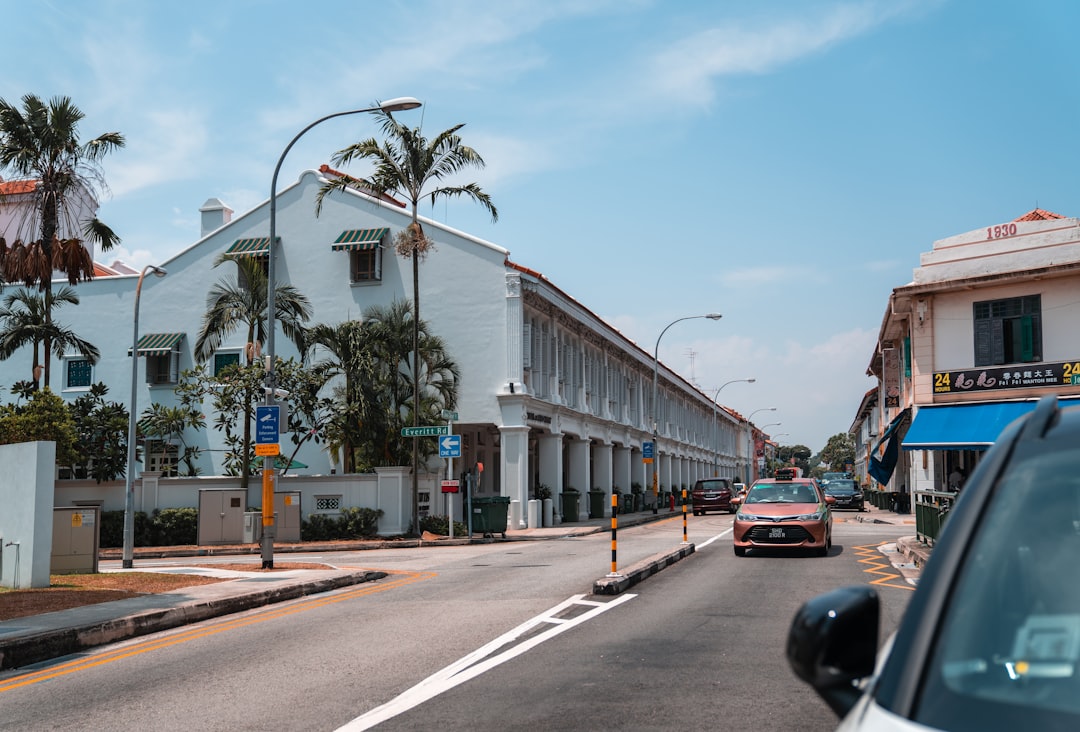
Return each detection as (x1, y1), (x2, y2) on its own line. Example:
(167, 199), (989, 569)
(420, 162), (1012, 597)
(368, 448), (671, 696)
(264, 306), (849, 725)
(853, 209), (1080, 509)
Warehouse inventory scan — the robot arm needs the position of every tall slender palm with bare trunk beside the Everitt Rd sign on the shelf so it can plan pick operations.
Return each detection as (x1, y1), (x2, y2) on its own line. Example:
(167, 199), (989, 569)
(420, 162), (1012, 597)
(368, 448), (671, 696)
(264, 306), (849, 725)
(315, 105), (499, 528)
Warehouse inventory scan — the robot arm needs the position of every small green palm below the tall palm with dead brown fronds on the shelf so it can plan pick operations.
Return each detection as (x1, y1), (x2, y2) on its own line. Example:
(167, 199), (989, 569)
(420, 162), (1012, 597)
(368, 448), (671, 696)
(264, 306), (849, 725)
(0, 286), (100, 390)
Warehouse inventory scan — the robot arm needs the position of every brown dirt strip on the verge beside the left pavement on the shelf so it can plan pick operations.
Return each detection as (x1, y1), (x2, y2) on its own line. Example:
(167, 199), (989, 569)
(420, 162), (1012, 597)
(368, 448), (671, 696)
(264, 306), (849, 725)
(0, 561), (332, 621)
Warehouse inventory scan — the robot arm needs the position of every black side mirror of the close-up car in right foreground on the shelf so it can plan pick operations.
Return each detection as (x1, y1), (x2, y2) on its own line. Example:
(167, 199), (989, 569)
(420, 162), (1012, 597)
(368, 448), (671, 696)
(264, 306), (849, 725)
(787, 585), (880, 718)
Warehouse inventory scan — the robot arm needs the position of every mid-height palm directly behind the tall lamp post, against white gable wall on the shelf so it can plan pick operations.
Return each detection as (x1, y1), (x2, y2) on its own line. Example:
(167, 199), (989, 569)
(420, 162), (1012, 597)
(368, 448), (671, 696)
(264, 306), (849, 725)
(194, 255), (311, 490)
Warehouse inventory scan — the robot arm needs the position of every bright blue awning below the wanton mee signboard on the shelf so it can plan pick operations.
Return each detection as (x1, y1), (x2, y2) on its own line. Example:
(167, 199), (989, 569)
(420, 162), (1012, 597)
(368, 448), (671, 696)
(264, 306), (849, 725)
(903, 399), (1077, 450)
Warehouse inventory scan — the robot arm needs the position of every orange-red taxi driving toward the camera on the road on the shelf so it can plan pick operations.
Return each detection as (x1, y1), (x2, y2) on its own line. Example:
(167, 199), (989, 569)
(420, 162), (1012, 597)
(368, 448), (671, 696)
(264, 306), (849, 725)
(732, 471), (836, 557)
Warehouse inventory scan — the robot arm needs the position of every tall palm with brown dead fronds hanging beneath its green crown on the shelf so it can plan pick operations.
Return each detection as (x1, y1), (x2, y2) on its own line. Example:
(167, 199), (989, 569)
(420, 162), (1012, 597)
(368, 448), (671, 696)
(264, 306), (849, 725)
(0, 94), (124, 387)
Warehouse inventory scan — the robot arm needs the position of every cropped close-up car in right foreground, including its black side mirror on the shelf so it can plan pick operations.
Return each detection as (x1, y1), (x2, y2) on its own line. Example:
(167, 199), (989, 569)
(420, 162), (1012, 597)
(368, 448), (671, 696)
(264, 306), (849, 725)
(787, 396), (1080, 732)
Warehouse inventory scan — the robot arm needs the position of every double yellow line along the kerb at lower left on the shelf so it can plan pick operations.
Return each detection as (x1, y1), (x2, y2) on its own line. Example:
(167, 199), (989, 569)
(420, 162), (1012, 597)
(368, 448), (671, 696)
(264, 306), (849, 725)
(0, 570), (436, 693)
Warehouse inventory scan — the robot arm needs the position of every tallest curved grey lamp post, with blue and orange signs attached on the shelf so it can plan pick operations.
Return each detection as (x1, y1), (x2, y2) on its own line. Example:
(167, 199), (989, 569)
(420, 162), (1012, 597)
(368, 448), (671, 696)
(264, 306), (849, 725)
(261, 96), (420, 569)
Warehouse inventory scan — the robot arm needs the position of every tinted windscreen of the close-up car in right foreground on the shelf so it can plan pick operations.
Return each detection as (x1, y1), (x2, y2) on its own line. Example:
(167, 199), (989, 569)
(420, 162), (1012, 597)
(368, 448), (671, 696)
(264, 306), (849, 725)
(916, 449), (1080, 730)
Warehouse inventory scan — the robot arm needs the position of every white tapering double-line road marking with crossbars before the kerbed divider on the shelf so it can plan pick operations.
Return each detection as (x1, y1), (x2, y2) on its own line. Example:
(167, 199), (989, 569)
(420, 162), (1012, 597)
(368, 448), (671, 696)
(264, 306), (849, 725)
(338, 595), (637, 732)
